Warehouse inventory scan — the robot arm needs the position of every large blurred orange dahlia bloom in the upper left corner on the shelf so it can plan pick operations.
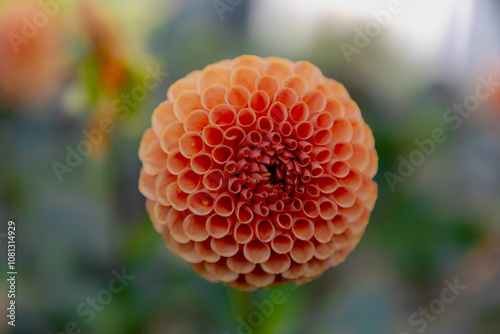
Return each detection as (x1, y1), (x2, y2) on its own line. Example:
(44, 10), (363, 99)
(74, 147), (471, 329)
(0, 0), (68, 106)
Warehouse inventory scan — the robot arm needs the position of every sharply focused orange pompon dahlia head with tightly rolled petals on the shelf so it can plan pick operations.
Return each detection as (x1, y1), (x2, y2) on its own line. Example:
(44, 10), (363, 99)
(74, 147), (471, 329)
(139, 56), (378, 290)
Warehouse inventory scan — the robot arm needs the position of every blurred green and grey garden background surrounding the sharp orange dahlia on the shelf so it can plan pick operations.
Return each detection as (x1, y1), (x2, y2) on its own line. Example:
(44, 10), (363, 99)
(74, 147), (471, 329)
(0, 0), (500, 334)
